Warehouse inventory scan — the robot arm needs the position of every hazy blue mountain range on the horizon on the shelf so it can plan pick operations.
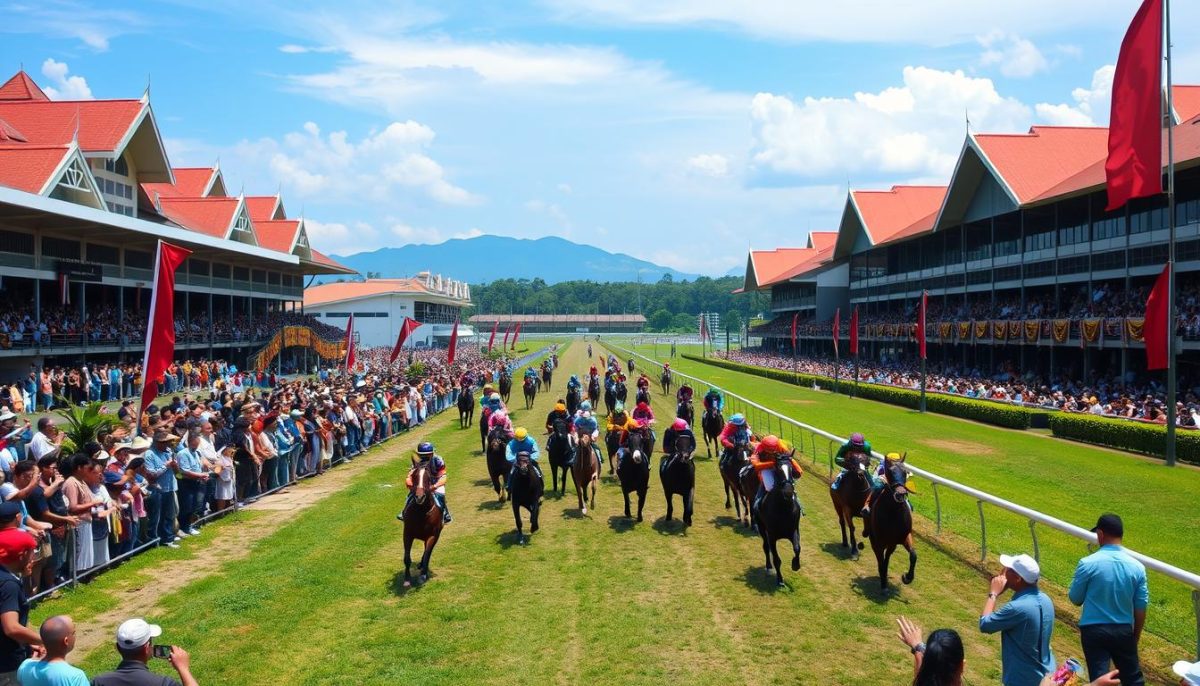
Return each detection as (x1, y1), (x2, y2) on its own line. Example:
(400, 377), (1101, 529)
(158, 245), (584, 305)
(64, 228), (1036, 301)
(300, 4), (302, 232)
(330, 235), (697, 283)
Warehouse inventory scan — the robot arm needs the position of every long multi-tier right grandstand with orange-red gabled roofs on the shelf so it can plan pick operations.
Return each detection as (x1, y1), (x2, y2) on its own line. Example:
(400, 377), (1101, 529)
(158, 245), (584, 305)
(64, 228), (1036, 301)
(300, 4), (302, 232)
(744, 86), (1200, 378)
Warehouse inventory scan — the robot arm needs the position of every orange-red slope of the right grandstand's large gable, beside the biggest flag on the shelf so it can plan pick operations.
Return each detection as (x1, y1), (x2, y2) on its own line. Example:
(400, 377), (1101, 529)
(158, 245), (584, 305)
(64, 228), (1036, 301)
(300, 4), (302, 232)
(974, 126), (1109, 205)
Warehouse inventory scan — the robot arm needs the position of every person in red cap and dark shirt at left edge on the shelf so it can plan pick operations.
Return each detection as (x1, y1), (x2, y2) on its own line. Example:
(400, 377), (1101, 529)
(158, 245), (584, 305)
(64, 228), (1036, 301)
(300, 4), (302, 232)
(0, 529), (42, 686)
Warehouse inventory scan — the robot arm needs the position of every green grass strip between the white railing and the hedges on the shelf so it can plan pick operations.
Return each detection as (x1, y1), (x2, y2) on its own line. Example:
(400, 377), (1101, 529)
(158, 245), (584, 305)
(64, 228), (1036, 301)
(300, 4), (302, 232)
(619, 345), (1200, 652)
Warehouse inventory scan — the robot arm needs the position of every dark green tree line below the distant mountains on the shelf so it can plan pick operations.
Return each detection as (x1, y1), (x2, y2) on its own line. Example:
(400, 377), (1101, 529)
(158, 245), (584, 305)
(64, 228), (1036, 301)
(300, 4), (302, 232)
(470, 275), (768, 332)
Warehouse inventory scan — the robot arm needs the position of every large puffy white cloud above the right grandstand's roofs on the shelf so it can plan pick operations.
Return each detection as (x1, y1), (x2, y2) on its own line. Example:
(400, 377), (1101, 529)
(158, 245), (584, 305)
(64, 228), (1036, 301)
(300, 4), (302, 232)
(750, 66), (1030, 179)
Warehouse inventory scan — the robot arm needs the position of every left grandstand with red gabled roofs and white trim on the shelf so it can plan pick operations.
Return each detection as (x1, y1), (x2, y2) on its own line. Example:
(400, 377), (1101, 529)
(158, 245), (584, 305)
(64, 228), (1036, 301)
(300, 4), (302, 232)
(0, 71), (354, 374)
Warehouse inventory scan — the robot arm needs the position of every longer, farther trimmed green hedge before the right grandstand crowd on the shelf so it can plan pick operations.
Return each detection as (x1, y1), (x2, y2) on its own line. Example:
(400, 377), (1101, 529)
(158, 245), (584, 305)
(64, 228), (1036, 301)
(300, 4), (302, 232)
(683, 354), (1045, 429)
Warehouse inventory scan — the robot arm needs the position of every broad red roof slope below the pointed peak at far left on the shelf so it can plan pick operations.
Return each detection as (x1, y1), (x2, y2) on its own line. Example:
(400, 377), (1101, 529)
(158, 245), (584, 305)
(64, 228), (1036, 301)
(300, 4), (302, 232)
(0, 100), (145, 152)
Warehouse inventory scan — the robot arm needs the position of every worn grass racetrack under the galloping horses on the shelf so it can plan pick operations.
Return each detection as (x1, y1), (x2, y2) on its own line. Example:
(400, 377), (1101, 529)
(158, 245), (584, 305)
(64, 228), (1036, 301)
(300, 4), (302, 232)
(35, 343), (1180, 686)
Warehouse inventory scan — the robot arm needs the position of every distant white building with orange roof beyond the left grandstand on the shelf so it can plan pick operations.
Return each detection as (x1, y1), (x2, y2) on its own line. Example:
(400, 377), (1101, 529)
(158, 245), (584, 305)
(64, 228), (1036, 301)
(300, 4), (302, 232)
(304, 271), (475, 347)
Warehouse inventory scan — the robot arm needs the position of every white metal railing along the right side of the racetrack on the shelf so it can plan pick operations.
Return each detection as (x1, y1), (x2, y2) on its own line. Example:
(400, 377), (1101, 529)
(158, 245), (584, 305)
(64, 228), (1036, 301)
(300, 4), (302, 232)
(605, 343), (1200, 657)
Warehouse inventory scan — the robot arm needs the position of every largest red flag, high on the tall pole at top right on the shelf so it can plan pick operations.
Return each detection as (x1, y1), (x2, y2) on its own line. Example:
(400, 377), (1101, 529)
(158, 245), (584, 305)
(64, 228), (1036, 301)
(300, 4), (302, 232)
(1104, 0), (1163, 210)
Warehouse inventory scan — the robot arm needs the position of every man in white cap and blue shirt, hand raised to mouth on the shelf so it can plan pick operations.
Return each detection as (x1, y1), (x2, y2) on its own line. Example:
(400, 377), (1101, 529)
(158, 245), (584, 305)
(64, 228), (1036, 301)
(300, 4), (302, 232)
(979, 555), (1055, 686)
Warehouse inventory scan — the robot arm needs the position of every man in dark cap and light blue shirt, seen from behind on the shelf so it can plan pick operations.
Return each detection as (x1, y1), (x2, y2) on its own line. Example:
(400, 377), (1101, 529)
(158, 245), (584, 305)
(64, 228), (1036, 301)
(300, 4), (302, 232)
(1067, 515), (1150, 686)
